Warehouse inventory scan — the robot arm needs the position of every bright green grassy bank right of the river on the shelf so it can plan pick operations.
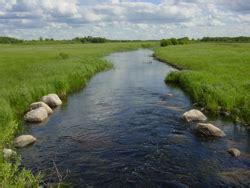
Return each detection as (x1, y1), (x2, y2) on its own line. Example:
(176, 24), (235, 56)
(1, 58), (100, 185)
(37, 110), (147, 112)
(155, 43), (250, 124)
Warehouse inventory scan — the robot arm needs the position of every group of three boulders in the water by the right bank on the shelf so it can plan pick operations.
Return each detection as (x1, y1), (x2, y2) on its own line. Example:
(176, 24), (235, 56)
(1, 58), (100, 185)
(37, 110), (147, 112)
(182, 109), (240, 157)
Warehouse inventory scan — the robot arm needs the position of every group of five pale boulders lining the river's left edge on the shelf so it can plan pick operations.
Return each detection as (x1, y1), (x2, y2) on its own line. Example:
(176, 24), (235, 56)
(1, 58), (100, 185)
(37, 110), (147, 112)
(3, 94), (62, 160)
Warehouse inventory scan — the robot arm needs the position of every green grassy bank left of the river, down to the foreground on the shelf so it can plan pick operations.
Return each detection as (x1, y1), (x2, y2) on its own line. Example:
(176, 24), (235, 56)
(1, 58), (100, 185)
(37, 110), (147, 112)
(0, 42), (156, 187)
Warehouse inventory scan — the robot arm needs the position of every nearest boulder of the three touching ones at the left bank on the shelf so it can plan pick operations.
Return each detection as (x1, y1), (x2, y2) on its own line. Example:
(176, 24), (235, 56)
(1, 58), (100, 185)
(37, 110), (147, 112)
(24, 107), (48, 123)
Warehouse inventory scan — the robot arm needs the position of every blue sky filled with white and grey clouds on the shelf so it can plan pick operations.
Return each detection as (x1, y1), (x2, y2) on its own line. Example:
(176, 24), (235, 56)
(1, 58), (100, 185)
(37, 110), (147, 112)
(0, 0), (250, 40)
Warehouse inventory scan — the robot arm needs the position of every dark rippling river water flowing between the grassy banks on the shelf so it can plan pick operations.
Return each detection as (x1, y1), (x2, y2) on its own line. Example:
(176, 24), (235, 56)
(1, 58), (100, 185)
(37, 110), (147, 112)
(20, 50), (250, 187)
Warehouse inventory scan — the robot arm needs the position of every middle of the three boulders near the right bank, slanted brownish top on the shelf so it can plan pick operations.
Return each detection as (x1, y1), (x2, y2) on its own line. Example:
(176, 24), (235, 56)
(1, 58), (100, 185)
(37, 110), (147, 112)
(196, 123), (226, 137)
